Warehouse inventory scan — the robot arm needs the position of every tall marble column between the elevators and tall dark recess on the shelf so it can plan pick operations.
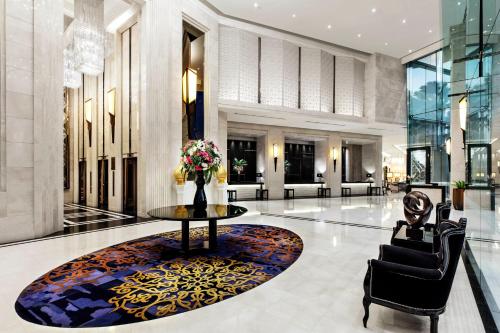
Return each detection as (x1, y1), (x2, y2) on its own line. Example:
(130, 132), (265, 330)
(138, 0), (182, 216)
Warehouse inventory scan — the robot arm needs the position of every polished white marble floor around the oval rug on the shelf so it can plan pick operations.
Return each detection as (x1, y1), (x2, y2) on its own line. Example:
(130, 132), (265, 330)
(0, 195), (484, 333)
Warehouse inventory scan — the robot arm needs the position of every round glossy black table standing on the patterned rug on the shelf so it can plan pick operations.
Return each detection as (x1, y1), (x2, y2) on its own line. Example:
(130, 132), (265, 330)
(148, 205), (247, 252)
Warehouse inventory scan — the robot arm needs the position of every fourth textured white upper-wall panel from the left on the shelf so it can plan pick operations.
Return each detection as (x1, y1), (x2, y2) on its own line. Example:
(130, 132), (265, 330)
(283, 42), (299, 109)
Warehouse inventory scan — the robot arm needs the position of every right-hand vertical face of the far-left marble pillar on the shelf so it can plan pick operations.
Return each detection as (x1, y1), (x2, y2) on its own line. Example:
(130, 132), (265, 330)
(33, 0), (64, 237)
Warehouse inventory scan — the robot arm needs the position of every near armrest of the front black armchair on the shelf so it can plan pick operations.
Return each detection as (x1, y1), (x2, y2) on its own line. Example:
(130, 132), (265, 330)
(368, 259), (442, 280)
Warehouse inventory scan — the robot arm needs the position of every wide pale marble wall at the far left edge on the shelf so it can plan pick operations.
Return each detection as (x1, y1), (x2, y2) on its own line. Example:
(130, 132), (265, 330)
(0, 0), (63, 243)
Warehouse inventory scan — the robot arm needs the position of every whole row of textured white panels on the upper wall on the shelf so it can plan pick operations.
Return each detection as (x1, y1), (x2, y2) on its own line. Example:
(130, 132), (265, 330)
(219, 25), (365, 117)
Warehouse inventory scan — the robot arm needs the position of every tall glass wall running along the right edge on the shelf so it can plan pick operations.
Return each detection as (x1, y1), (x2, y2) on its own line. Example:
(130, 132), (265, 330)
(442, 0), (500, 331)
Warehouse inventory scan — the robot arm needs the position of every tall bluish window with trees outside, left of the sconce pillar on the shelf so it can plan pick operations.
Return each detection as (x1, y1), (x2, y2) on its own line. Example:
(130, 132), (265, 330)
(407, 48), (451, 186)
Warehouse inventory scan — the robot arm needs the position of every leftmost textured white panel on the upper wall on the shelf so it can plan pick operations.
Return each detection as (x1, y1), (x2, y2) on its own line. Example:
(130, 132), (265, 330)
(219, 26), (240, 101)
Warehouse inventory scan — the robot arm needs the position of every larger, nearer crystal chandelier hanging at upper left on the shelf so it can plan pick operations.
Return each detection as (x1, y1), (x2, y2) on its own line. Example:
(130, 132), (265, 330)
(73, 0), (105, 76)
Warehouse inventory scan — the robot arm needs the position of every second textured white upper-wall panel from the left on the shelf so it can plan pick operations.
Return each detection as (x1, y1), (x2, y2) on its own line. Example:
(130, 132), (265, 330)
(238, 30), (259, 103)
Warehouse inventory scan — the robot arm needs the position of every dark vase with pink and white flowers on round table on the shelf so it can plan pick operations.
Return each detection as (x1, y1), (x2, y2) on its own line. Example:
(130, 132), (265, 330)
(181, 140), (222, 209)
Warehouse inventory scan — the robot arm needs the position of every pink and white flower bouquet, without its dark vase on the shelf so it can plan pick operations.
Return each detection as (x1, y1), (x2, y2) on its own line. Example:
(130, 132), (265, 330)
(181, 140), (222, 183)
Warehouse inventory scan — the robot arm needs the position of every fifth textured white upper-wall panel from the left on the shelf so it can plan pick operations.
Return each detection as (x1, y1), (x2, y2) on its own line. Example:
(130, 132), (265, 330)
(300, 47), (321, 111)
